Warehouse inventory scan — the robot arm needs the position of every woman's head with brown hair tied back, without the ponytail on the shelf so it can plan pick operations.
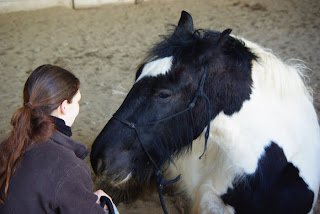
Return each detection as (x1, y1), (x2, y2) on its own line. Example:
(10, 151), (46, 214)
(23, 65), (81, 126)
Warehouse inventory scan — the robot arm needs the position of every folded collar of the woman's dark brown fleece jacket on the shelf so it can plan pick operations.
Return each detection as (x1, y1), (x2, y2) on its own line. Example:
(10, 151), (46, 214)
(50, 131), (89, 160)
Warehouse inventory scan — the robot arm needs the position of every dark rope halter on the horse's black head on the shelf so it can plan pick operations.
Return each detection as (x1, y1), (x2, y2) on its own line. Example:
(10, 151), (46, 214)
(113, 68), (211, 214)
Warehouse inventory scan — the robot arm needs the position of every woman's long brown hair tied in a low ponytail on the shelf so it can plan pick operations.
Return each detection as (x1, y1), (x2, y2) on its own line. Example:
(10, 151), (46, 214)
(0, 65), (80, 204)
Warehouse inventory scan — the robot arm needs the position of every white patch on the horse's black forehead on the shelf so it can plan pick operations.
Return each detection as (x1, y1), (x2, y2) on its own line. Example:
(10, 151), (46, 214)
(136, 56), (173, 83)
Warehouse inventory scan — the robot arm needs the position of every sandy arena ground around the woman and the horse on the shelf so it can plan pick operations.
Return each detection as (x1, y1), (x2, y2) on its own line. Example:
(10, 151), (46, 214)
(0, 0), (320, 213)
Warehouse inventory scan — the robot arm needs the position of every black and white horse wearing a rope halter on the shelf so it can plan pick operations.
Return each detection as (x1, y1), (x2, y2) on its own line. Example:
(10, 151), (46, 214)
(90, 11), (320, 214)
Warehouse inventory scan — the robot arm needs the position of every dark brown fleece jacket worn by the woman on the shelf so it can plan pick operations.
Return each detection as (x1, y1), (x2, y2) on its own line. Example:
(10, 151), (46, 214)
(0, 131), (104, 214)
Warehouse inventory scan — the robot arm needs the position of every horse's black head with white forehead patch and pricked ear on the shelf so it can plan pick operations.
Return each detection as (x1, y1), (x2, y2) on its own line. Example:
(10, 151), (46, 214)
(91, 11), (255, 196)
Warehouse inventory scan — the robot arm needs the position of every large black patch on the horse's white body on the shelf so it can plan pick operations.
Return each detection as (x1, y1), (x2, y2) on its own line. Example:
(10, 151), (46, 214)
(221, 142), (314, 214)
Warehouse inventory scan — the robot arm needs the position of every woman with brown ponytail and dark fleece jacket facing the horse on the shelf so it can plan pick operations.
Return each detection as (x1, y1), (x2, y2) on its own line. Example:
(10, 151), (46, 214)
(0, 65), (117, 214)
